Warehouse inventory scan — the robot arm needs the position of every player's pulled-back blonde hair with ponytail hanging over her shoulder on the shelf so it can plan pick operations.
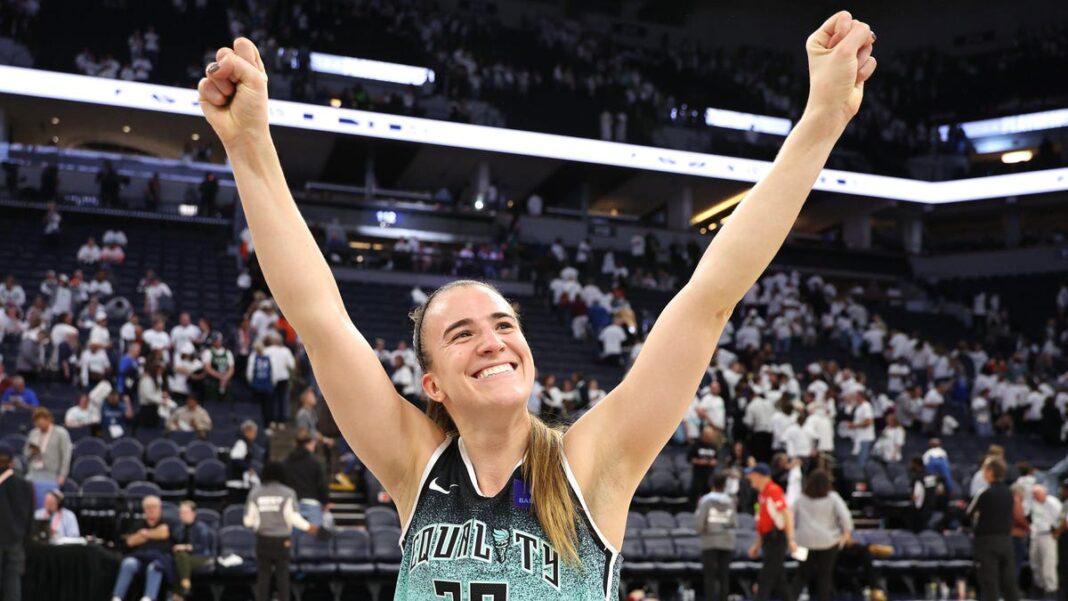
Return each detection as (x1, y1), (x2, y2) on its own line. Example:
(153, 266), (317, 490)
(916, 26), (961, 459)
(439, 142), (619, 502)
(410, 280), (581, 567)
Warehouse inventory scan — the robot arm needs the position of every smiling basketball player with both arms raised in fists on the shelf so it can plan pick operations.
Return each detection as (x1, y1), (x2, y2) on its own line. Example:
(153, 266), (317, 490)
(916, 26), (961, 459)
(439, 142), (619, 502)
(199, 12), (876, 601)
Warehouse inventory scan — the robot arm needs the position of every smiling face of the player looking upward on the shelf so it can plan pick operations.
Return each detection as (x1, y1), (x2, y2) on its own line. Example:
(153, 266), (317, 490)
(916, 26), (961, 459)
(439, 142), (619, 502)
(422, 286), (534, 415)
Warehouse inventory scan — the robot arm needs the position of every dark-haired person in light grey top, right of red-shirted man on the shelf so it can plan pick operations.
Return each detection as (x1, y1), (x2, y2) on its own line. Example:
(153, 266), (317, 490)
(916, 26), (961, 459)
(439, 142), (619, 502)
(794, 470), (853, 601)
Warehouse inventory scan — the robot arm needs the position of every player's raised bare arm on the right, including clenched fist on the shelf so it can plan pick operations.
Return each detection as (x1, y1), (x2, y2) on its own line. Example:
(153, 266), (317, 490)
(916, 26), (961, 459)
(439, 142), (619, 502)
(567, 12), (875, 494)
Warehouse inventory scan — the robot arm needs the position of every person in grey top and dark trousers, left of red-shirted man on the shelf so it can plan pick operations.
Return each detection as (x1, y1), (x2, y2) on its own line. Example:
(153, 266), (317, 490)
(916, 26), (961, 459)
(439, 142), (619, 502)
(694, 472), (738, 601)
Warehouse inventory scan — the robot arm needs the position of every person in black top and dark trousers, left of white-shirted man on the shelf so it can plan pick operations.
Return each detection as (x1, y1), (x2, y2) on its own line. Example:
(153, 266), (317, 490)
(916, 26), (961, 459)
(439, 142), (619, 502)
(967, 458), (1016, 601)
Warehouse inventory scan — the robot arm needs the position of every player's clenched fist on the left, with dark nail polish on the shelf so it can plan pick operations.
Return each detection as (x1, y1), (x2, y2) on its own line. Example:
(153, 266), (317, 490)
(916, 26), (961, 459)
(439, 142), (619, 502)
(197, 37), (270, 153)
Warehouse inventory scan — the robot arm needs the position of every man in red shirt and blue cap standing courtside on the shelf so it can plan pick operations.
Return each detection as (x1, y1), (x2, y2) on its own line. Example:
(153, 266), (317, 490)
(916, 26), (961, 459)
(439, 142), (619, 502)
(745, 463), (797, 601)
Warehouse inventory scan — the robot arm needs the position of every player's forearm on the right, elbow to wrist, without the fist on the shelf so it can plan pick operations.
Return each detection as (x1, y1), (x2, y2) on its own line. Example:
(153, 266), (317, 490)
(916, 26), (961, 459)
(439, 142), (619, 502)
(689, 112), (846, 311)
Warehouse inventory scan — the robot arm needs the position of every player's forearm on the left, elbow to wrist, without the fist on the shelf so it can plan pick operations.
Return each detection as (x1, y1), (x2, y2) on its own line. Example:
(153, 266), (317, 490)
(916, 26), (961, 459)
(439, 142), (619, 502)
(227, 136), (346, 338)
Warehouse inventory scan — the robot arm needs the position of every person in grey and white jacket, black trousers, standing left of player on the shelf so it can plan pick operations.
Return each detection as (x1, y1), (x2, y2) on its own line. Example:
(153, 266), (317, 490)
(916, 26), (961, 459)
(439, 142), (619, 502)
(244, 461), (318, 601)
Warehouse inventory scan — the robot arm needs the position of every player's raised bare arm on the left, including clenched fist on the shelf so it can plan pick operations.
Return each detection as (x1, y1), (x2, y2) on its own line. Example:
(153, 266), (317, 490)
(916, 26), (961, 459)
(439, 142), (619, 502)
(198, 37), (443, 511)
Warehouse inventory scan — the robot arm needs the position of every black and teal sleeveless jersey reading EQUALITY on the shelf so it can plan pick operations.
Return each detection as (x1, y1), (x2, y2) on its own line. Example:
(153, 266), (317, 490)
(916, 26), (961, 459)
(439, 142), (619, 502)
(394, 438), (623, 601)
